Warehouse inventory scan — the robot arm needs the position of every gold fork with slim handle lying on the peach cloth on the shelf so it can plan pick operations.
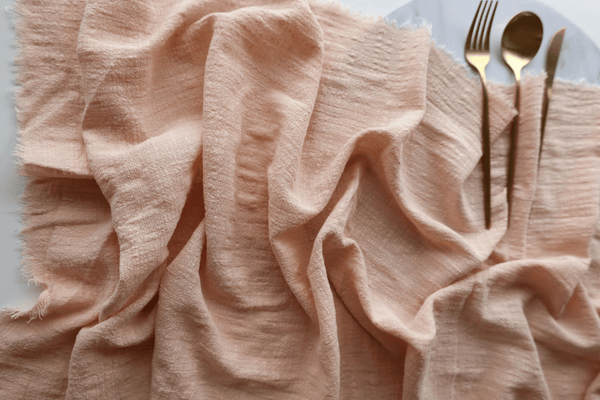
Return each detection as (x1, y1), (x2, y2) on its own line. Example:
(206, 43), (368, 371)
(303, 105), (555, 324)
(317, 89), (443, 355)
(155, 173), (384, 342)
(465, 0), (498, 229)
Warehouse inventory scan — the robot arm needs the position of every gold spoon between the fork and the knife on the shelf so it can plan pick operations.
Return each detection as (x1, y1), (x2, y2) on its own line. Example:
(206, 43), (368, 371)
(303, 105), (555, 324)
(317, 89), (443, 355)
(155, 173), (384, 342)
(501, 11), (544, 207)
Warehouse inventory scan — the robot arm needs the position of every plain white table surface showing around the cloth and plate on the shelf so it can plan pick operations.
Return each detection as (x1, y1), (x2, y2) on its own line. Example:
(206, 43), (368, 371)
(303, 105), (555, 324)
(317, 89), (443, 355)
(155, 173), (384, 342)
(0, 0), (600, 308)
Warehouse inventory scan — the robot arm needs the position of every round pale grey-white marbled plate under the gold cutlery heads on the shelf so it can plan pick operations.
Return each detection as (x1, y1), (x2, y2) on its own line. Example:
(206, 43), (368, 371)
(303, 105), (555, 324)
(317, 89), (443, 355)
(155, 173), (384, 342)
(386, 0), (600, 85)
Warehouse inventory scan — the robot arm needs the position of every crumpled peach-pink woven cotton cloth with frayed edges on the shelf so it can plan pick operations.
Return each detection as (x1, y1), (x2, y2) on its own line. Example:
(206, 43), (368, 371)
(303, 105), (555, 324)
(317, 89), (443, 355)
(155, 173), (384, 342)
(0, 0), (600, 400)
